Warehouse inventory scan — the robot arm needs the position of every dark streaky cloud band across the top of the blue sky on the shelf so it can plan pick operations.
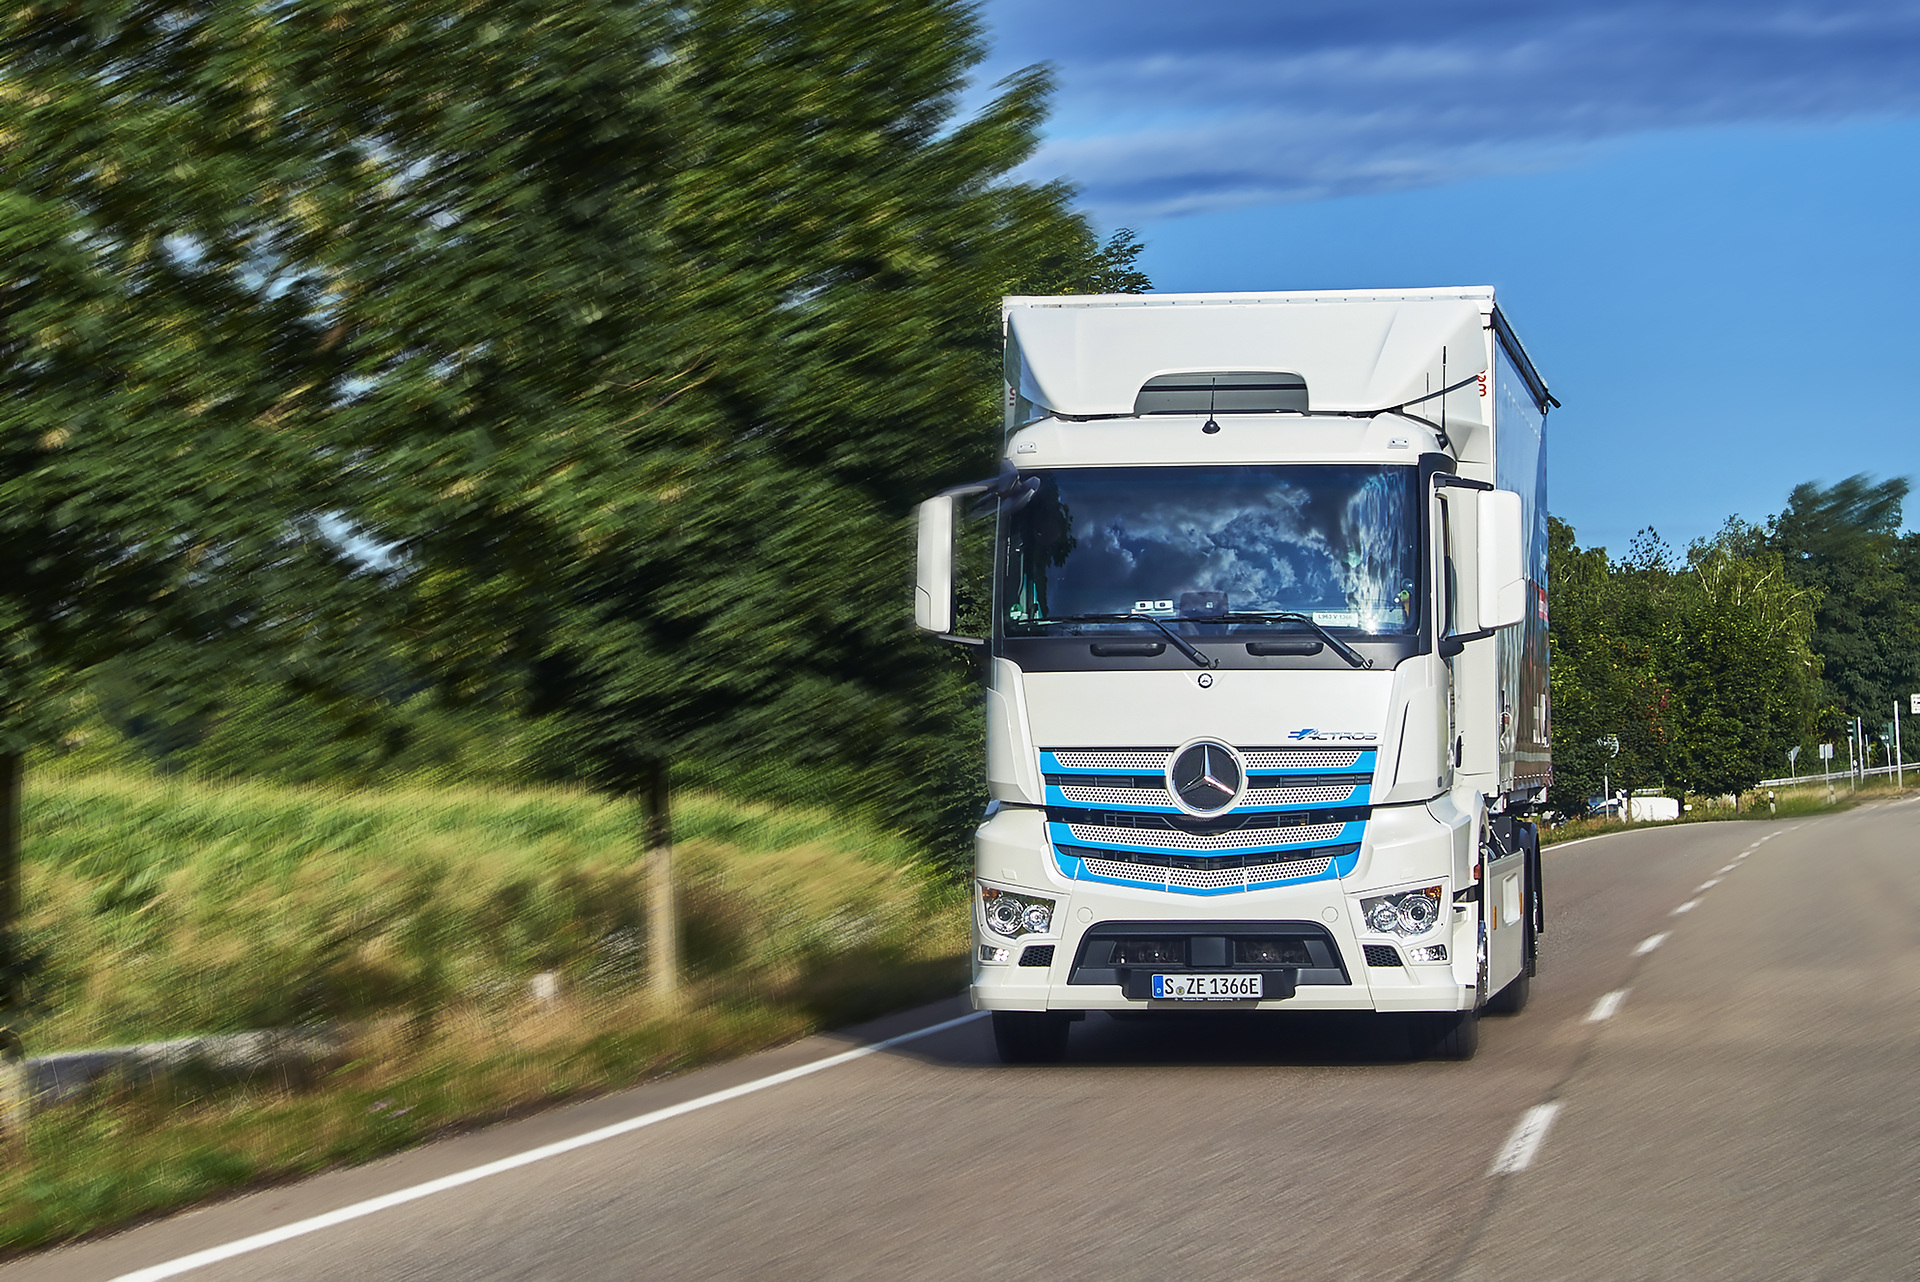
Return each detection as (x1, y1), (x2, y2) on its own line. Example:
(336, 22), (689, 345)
(985, 0), (1920, 221)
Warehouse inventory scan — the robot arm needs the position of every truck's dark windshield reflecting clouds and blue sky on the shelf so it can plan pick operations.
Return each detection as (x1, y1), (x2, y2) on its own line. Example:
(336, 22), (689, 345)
(1000, 464), (1419, 637)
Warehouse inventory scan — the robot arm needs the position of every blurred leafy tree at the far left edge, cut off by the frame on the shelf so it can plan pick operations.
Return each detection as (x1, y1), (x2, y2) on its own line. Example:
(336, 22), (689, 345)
(0, 4), (366, 1048)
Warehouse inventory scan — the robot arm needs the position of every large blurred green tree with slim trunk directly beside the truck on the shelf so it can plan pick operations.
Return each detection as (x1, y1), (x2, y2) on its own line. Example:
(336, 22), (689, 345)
(289, 0), (1139, 983)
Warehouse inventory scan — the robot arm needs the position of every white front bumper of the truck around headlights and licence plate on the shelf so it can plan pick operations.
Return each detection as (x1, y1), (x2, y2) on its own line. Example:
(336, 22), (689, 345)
(970, 806), (1478, 1011)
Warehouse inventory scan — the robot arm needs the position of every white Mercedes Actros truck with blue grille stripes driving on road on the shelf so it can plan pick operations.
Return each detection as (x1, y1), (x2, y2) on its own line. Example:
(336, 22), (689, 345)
(914, 288), (1557, 1061)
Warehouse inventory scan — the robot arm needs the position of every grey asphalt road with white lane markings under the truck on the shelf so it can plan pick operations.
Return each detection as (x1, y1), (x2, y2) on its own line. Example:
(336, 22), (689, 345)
(15, 800), (1920, 1282)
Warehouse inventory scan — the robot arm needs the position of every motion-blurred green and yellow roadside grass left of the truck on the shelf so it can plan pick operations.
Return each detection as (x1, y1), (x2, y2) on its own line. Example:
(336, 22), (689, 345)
(0, 772), (968, 1247)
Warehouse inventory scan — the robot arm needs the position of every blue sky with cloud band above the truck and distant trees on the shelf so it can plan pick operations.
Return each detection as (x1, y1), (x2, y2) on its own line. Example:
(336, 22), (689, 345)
(981, 0), (1920, 555)
